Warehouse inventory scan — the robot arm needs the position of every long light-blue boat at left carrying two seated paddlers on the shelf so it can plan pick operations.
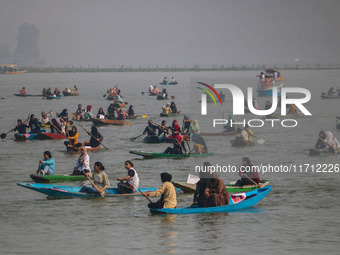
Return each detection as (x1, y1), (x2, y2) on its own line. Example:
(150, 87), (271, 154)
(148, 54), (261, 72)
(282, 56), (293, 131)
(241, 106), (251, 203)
(18, 183), (181, 198)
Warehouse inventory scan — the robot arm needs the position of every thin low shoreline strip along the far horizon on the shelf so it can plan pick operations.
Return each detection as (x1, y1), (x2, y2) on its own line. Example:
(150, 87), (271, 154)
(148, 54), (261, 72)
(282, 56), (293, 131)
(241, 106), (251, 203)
(11, 65), (340, 73)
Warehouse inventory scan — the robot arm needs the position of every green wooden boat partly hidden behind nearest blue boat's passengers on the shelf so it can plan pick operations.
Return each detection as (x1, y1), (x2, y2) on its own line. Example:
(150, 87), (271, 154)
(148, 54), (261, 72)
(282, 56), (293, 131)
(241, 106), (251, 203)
(172, 180), (269, 193)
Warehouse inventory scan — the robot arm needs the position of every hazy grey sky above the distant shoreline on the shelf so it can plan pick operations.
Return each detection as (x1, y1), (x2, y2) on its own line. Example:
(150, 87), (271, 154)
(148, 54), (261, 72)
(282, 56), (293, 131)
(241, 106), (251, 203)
(0, 0), (340, 66)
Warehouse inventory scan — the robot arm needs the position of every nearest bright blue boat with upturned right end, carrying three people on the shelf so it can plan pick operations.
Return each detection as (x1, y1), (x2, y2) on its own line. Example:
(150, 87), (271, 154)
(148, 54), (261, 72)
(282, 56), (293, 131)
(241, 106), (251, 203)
(150, 186), (272, 214)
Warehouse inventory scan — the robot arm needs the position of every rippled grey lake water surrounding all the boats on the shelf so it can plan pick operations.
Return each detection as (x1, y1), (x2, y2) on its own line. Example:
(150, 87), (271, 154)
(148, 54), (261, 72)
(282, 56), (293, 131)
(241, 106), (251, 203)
(0, 70), (340, 255)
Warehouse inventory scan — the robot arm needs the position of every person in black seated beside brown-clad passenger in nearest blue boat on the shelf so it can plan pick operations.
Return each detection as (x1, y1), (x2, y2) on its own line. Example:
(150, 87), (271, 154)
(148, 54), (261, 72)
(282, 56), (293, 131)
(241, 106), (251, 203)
(193, 162), (211, 207)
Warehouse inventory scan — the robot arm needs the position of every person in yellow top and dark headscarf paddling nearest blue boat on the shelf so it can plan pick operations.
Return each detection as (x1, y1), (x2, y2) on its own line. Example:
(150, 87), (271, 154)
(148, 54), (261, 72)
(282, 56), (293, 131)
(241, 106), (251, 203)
(143, 173), (177, 208)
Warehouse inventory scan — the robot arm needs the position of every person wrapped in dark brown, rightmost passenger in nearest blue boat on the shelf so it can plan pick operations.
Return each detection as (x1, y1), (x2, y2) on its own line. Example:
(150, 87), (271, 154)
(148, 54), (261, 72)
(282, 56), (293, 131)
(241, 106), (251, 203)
(203, 172), (229, 207)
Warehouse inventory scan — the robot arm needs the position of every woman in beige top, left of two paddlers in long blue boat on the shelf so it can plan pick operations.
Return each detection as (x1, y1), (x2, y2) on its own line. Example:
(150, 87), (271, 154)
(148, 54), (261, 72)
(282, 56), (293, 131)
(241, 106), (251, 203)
(79, 161), (111, 194)
